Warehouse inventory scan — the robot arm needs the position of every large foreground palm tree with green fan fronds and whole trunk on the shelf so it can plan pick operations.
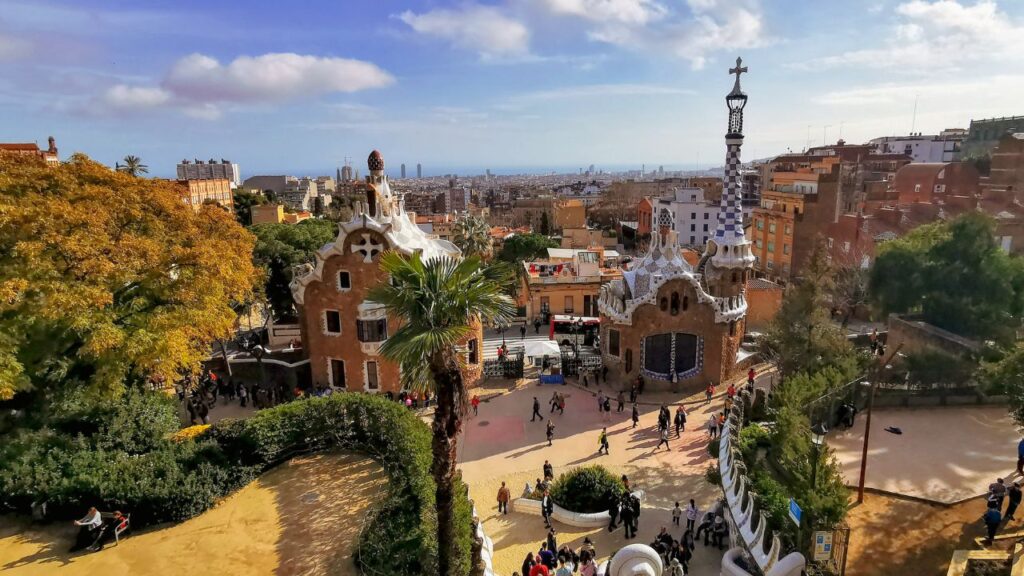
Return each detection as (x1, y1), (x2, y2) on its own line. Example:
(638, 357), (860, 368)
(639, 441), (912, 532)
(367, 251), (515, 576)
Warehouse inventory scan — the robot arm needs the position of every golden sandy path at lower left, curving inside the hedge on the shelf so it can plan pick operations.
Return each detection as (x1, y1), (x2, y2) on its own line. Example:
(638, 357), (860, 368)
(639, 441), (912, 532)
(0, 454), (386, 576)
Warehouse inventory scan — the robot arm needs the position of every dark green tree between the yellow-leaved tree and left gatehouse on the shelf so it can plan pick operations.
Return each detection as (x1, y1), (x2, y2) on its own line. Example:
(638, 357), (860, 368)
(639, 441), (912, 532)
(250, 218), (338, 320)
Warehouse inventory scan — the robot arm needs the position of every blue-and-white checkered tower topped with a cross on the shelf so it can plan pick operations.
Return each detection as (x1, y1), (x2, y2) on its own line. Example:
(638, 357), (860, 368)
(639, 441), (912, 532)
(709, 58), (754, 269)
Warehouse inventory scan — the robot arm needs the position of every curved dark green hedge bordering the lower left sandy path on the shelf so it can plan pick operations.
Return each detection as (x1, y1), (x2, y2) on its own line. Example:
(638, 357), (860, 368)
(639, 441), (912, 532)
(0, 394), (473, 574)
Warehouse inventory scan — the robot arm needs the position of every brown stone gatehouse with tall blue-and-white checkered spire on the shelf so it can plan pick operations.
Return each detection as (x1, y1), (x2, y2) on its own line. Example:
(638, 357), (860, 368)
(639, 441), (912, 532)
(599, 58), (754, 390)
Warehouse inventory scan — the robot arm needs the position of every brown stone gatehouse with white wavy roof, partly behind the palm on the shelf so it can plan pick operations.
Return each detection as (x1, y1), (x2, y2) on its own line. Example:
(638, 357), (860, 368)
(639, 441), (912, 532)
(291, 151), (483, 393)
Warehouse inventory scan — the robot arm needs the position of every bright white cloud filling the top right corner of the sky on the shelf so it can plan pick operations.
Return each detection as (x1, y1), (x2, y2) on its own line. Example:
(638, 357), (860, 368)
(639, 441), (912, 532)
(795, 0), (1024, 73)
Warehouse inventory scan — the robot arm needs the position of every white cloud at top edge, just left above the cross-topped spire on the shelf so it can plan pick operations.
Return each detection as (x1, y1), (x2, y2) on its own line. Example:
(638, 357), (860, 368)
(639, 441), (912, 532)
(543, 0), (768, 69)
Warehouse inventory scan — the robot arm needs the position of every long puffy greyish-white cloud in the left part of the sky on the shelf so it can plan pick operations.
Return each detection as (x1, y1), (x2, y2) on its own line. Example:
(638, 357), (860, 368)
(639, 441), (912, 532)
(162, 53), (394, 102)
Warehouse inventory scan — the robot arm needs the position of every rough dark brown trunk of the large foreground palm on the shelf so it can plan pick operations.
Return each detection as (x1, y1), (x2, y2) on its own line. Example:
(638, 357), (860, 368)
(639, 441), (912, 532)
(430, 352), (466, 576)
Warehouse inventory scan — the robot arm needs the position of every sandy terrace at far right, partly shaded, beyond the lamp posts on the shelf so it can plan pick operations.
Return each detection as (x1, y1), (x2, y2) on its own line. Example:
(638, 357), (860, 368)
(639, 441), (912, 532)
(828, 406), (1020, 504)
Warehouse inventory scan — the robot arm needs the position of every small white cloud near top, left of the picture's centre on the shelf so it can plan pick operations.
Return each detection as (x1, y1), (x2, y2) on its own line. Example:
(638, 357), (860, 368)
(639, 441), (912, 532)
(396, 4), (529, 58)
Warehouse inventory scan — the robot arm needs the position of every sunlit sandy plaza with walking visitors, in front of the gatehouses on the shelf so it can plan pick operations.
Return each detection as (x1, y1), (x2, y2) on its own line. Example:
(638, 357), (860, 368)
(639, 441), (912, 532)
(460, 379), (722, 576)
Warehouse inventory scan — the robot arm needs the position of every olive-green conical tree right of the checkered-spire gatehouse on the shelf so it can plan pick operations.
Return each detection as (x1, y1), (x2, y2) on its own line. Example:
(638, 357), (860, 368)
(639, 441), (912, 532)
(760, 244), (856, 378)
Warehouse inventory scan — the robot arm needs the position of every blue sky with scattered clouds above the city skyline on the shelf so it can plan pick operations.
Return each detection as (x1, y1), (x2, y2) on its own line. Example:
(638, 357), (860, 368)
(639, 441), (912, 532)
(0, 0), (1024, 177)
